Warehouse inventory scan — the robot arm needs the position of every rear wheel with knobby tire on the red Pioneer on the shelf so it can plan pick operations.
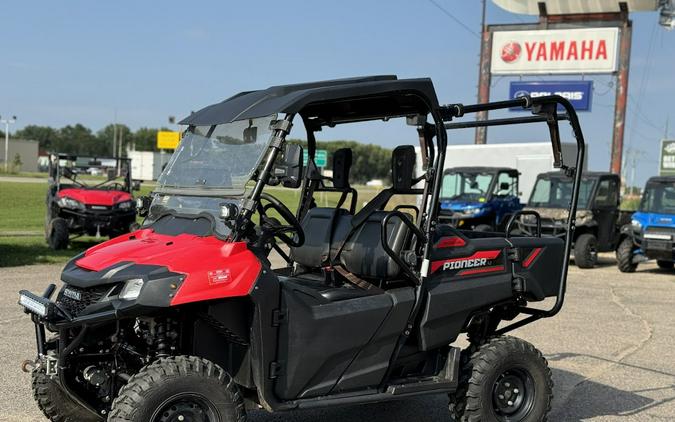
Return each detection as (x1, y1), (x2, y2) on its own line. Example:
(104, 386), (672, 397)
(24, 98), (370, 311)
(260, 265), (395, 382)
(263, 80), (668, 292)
(450, 336), (553, 422)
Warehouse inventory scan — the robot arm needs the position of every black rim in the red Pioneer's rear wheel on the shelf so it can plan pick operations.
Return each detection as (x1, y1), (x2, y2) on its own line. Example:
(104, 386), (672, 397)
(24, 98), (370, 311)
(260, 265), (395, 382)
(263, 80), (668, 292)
(492, 368), (534, 421)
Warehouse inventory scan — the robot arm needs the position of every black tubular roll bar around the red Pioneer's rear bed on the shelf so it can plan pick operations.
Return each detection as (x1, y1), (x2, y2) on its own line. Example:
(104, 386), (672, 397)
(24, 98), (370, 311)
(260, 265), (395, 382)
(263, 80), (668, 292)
(440, 95), (586, 326)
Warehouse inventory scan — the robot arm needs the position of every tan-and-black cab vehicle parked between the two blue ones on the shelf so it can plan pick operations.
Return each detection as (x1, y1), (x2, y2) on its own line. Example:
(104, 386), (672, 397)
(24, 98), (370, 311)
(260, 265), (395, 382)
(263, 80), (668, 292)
(518, 172), (630, 268)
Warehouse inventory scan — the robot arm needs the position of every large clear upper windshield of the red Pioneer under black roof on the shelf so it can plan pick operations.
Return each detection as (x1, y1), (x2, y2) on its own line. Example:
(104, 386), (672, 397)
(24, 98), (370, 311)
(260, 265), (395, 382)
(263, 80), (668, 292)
(156, 115), (276, 196)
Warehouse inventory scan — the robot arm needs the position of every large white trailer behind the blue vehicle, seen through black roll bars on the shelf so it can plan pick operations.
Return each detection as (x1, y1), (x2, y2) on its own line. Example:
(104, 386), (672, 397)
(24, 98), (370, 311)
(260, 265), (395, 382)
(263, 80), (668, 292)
(416, 142), (588, 203)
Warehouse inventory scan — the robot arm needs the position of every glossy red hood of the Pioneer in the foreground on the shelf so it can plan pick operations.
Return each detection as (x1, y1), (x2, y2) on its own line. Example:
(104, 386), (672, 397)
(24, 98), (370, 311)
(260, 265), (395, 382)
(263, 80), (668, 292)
(76, 229), (261, 305)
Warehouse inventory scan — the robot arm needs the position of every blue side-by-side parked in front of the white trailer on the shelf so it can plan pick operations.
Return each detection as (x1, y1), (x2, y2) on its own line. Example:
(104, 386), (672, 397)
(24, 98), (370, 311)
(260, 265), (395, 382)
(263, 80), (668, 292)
(439, 167), (523, 232)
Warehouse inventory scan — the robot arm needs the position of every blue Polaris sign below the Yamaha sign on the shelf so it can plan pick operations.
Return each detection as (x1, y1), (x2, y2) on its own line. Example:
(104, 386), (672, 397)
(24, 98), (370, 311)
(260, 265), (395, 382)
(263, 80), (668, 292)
(509, 81), (593, 111)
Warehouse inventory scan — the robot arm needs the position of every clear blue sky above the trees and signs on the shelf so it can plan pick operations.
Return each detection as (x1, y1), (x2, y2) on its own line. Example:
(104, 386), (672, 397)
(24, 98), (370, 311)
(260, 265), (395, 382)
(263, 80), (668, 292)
(0, 0), (675, 184)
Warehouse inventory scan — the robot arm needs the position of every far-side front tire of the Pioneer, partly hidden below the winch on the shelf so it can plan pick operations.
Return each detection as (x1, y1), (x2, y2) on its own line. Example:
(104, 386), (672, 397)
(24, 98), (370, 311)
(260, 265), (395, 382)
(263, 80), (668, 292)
(32, 370), (101, 422)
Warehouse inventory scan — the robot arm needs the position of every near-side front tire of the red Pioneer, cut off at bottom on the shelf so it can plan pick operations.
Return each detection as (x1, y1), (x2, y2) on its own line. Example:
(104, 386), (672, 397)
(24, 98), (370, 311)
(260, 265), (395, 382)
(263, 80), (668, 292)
(108, 356), (246, 422)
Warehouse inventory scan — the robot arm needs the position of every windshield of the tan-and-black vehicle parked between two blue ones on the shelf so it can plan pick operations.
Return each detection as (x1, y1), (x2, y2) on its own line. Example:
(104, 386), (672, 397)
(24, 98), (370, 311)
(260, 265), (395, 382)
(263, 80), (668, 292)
(528, 177), (595, 208)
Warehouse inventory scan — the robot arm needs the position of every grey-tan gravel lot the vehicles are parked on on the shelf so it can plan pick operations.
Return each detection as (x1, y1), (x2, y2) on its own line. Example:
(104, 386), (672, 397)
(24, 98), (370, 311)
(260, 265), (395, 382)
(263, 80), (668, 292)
(0, 256), (675, 422)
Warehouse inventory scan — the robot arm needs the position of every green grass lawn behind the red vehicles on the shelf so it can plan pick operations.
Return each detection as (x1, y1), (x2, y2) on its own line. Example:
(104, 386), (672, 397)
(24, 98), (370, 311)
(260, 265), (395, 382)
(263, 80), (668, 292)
(0, 178), (415, 267)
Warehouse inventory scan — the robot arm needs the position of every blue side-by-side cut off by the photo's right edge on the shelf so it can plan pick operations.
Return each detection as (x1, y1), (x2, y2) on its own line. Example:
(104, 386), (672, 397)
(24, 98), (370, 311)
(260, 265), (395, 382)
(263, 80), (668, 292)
(616, 176), (675, 273)
